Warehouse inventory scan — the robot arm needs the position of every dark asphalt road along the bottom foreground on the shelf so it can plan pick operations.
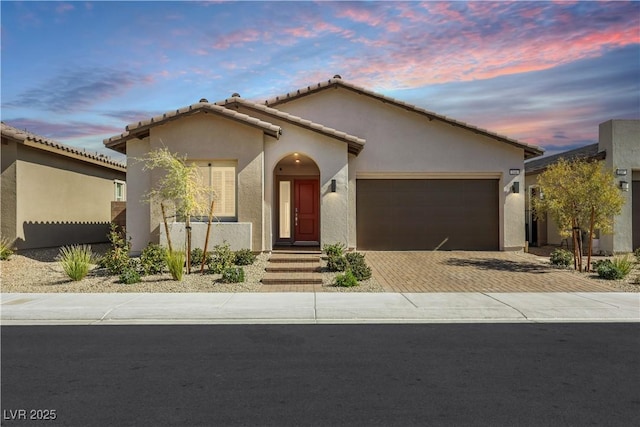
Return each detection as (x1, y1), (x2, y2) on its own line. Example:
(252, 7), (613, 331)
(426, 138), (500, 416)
(1, 324), (640, 426)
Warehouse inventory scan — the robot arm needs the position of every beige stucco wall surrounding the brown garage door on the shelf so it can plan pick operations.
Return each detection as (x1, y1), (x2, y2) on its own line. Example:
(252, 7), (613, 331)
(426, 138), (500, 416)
(278, 88), (526, 250)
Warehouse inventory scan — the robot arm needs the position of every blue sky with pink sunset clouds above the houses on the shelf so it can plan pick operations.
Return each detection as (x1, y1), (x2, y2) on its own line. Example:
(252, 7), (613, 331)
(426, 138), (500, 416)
(0, 0), (640, 164)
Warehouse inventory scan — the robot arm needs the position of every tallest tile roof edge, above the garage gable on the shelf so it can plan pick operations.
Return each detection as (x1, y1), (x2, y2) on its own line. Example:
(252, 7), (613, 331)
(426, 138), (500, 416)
(264, 76), (544, 159)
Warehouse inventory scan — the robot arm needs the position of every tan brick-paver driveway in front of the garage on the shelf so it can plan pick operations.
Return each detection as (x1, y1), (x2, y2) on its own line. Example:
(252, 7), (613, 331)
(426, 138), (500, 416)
(365, 251), (614, 292)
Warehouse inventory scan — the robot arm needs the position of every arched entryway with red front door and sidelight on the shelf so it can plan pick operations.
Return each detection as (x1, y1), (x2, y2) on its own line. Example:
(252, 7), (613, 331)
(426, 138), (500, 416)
(273, 152), (320, 246)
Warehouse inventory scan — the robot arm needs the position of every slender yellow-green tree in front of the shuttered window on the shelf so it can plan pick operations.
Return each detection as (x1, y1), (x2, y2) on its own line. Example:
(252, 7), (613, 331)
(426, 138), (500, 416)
(142, 147), (209, 272)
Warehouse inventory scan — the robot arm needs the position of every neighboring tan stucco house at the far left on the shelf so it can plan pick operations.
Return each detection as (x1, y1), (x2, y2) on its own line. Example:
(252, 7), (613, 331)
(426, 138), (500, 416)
(0, 123), (126, 249)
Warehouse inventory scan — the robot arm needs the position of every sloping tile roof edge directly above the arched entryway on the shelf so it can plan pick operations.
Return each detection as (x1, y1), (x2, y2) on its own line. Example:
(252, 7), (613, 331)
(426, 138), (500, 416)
(216, 96), (366, 155)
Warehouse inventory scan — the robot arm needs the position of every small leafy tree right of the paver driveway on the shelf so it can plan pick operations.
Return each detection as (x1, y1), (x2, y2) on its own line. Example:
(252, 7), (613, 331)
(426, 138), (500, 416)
(533, 158), (624, 271)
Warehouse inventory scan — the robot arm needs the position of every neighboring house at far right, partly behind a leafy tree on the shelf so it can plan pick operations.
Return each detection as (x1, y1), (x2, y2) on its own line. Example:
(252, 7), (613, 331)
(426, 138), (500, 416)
(525, 120), (640, 253)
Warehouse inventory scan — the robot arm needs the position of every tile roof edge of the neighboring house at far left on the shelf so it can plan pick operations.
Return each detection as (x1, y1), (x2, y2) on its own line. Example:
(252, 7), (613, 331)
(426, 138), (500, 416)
(1, 122), (127, 172)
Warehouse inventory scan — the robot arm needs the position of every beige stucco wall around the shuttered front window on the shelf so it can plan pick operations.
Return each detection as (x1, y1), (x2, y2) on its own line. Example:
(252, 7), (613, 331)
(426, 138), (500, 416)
(127, 114), (264, 253)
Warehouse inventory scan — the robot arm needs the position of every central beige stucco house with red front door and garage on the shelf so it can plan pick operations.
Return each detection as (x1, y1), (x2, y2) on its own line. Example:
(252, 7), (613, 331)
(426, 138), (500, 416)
(105, 76), (542, 252)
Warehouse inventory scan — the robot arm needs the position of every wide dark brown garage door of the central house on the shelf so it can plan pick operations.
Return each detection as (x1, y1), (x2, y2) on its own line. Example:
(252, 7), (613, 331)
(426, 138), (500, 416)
(356, 179), (500, 250)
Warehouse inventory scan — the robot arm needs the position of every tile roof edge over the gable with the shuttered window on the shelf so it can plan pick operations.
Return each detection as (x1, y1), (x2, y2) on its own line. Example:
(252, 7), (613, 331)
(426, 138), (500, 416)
(104, 102), (282, 153)
